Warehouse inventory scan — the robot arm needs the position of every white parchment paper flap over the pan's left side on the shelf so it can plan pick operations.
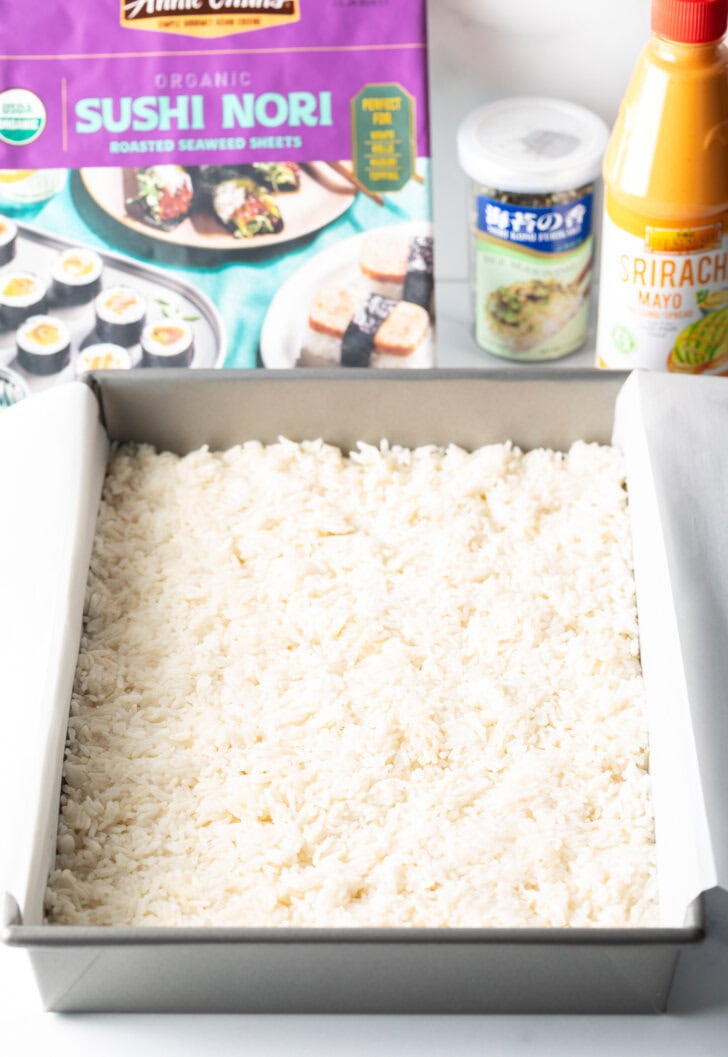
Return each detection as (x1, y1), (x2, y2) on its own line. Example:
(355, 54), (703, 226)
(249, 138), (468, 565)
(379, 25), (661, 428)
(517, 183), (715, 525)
(0, 383), (109, 925)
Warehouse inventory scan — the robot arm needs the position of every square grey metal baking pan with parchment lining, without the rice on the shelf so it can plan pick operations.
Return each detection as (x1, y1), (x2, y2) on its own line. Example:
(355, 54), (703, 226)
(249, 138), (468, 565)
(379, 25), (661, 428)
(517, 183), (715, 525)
(0, 369), (728, 1013)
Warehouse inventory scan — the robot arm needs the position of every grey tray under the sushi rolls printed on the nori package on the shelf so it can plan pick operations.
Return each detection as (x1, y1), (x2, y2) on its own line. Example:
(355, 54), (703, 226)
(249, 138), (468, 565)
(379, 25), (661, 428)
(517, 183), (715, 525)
(0, 221), (227, 392)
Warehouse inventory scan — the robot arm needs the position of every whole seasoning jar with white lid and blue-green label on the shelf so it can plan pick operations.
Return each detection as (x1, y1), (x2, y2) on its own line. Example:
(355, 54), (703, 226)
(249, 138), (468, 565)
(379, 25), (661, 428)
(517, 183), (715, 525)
(458, 98), (609, 361)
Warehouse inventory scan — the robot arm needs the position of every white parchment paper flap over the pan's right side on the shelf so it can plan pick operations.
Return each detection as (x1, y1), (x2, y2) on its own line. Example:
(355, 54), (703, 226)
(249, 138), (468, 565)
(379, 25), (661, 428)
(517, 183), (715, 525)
(614, 372), (728, 926)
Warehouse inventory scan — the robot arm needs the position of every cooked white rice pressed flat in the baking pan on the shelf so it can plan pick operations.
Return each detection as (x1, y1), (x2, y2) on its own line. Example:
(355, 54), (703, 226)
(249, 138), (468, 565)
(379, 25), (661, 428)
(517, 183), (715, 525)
(46, 441), (657, 926)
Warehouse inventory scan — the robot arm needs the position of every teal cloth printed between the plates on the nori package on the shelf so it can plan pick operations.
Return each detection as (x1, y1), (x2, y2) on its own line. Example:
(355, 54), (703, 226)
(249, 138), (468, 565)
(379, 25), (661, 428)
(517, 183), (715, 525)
(0, 167), (431, 368)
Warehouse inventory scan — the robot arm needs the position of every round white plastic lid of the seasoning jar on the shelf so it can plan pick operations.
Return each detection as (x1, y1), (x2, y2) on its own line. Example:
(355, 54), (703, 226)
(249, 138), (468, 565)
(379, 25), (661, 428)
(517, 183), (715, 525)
(458, 97), (610, 194)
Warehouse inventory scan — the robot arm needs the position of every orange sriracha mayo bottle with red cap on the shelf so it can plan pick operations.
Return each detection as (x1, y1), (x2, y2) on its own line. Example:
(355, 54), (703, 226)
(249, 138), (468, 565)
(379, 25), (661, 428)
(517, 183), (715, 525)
(597, 0), (728, 374)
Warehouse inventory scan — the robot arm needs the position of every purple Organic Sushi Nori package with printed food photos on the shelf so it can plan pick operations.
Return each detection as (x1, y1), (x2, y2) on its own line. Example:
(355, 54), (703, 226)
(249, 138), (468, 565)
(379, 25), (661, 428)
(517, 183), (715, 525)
(0, 0), (435, 394)
